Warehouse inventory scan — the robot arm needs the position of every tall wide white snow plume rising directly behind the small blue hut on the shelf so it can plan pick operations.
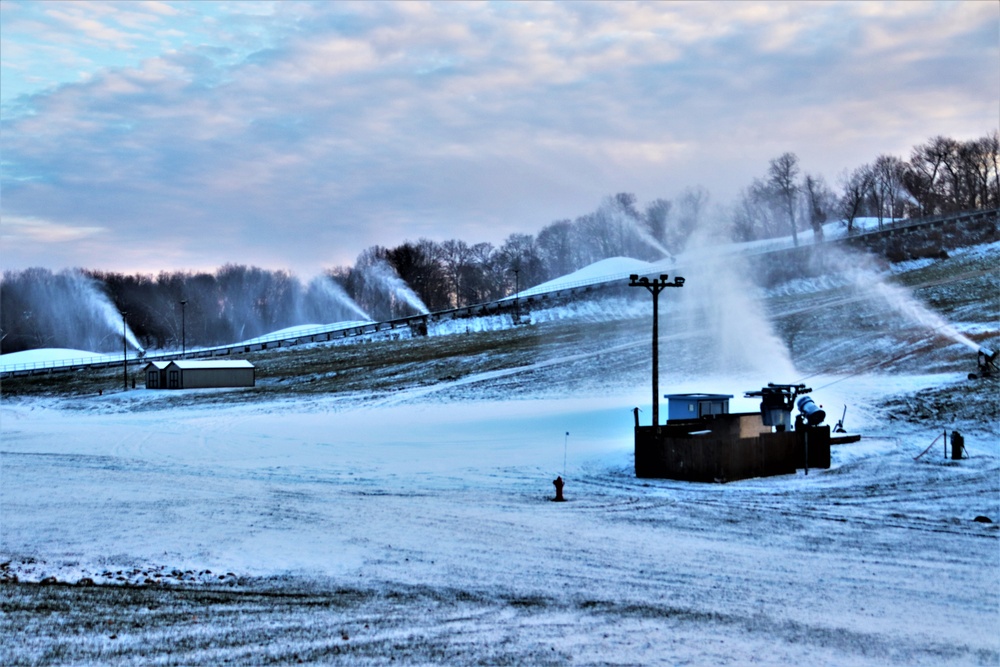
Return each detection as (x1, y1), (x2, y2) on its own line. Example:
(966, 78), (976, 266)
(676, 224), (799, 383)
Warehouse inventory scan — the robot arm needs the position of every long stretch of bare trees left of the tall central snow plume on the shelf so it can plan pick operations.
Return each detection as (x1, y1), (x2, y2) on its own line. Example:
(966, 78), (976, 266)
(0, 189), (708, 353)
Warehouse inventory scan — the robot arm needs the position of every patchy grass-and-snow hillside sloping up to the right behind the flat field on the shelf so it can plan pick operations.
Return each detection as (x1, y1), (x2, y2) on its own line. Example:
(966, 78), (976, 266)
(2, 237), (1000, 428)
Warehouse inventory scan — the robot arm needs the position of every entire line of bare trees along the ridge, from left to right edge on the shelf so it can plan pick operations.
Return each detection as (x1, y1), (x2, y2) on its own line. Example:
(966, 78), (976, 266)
(0, 131), (1000, 353)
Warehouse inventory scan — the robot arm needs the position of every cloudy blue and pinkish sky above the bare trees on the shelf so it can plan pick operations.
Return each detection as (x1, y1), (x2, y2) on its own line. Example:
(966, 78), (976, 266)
(0, 0), (1000, 277)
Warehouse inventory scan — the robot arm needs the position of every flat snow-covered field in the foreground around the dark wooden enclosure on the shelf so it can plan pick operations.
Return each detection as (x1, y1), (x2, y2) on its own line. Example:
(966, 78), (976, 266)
(0, 368), (1000, 665)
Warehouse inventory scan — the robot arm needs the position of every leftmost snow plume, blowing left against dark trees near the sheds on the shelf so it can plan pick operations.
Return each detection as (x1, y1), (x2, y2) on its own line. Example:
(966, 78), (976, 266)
(0, 268), (143, 352)
